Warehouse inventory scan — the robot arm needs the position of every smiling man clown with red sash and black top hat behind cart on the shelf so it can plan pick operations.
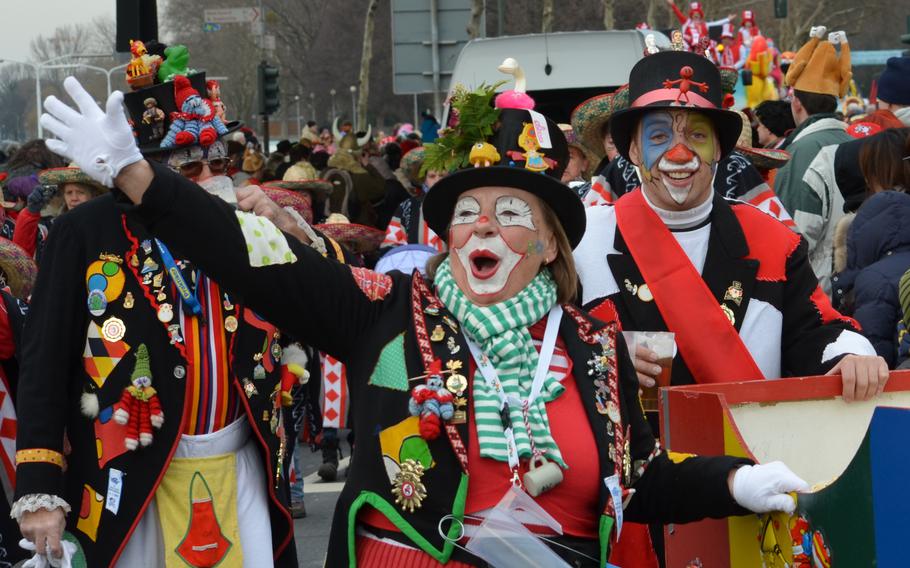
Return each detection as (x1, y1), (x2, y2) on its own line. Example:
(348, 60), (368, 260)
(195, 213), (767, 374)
(575, 51), (888, 401)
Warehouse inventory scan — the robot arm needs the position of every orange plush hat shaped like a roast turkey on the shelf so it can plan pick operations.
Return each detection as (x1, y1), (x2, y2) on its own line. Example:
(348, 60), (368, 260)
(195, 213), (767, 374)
(786, 26), (853, 98)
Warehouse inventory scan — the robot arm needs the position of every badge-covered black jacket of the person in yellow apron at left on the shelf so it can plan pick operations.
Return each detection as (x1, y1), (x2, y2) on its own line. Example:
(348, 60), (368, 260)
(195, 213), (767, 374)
(16, 194), (297, 566)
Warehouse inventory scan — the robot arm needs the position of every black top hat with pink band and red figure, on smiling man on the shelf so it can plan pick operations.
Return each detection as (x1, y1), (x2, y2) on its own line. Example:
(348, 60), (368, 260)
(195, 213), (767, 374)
(610, 51), (742, 159)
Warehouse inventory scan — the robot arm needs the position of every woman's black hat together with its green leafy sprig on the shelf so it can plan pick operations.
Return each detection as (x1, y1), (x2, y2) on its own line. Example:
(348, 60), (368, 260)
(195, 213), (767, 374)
(423, 80), (586, 247)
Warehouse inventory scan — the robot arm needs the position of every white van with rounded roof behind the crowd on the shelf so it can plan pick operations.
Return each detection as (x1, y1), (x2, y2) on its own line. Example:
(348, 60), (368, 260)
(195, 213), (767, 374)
(443, 30), (670, 124)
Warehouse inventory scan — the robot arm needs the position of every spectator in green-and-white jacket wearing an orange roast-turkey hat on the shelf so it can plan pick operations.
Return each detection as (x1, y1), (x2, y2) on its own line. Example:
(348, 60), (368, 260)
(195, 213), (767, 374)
(774, 26), (853, 293)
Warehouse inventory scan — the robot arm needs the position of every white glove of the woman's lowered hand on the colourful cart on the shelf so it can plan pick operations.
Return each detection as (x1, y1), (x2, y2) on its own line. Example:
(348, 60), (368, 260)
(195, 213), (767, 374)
(733, 462), (809, 513)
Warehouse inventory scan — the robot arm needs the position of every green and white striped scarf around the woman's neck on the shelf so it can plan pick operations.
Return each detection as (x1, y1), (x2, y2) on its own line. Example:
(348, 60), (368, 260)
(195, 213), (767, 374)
(435, 259), (567, 468)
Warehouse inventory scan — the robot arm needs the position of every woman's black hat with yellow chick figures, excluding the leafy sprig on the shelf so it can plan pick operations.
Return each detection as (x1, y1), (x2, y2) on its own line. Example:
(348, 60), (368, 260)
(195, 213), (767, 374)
(423, 109), (585, 248)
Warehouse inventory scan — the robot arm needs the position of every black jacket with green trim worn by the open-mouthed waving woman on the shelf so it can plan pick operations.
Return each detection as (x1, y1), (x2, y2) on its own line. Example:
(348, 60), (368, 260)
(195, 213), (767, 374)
(116, 165), (748, 567)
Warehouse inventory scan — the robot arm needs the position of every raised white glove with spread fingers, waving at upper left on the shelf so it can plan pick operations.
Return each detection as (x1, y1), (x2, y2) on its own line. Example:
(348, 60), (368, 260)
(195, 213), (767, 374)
(41, 77), (142, 187)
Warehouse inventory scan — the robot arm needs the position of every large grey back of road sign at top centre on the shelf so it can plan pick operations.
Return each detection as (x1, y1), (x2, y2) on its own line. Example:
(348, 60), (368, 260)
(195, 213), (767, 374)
(391, 0), (483, 95)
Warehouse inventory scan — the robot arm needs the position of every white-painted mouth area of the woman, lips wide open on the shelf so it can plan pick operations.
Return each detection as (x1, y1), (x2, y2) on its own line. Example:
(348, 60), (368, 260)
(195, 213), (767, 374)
(453, 233), (523, 296)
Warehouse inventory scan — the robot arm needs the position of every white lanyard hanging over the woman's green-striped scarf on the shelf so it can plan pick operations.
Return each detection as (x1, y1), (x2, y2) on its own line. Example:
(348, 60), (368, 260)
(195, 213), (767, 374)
(464, 305), (562, 474)
